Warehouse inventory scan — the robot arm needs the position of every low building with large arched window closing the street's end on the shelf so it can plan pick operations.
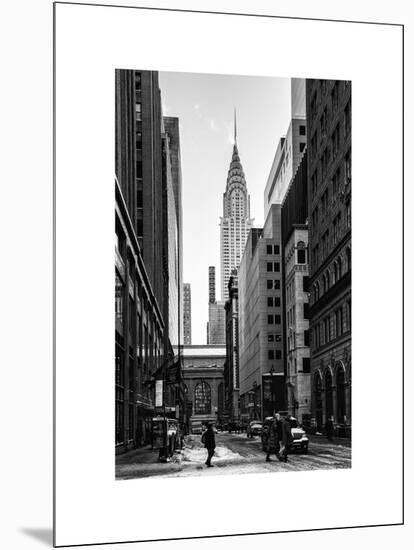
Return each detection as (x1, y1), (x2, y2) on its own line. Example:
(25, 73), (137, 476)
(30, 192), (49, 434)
(175, 346), (226, 433)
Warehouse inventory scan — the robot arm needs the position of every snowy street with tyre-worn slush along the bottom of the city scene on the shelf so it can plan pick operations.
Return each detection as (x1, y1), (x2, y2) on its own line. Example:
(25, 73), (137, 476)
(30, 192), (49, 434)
(116, 432), (351, 479)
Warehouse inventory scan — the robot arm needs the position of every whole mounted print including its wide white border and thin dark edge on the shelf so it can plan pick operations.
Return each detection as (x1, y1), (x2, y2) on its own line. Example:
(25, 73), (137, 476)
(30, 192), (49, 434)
(46, 0), (404, 548)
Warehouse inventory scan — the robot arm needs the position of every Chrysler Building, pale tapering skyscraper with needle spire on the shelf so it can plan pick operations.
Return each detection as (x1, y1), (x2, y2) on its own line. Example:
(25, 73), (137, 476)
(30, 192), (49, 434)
(220, 112), (253, 301)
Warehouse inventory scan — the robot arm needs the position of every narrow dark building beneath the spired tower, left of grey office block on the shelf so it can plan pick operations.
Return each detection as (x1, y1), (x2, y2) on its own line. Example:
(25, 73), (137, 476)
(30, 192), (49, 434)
(224, 269), (240, 421)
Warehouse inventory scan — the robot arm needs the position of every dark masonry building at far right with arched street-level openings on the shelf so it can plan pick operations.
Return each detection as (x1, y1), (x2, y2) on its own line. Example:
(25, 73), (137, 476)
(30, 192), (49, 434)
(306, 80), (352, 435)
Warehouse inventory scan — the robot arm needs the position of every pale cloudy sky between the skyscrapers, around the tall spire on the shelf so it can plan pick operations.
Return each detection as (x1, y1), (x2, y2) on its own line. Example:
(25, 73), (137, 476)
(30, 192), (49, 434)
(159, 72), (290, 345)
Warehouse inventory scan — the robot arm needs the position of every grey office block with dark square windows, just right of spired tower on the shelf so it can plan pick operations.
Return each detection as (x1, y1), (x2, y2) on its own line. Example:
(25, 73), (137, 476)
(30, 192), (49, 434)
(238, 204), (286, 419)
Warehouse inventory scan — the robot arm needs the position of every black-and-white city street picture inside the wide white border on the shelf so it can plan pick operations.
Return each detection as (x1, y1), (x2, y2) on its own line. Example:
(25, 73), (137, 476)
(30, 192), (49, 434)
(114, 69), (352, 480)
